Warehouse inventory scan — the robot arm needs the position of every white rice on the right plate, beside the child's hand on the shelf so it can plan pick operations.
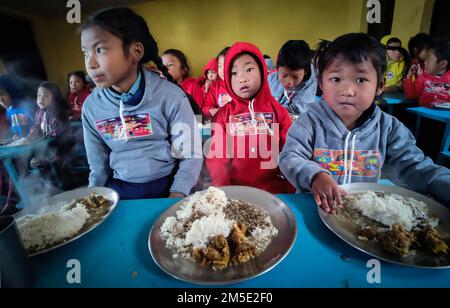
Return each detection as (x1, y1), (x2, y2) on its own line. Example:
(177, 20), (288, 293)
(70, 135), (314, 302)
(346, 191), (437, 230)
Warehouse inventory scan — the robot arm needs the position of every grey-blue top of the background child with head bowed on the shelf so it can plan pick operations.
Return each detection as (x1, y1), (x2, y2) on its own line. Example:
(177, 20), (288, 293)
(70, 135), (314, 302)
(267, 65), (317, 114)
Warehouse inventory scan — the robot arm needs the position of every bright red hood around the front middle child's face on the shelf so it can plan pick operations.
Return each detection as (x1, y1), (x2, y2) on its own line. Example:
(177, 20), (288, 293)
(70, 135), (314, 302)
(224, 42), (274, 105)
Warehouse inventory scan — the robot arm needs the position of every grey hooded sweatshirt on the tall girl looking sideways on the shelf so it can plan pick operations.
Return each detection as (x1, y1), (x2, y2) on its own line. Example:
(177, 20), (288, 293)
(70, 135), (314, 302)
(82, 71), (203, 195)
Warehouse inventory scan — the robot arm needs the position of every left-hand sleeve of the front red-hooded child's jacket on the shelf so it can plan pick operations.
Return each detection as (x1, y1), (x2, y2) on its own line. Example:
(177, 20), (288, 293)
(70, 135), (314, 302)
(206, 109), (231, 186)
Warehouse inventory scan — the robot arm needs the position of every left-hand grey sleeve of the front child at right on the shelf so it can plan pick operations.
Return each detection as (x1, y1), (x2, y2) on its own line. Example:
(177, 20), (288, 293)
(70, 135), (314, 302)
(280, 114), (330, 191)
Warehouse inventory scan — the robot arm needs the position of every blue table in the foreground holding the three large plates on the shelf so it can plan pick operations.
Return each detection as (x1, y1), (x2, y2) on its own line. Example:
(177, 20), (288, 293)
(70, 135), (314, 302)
(32, 194), (450, 288)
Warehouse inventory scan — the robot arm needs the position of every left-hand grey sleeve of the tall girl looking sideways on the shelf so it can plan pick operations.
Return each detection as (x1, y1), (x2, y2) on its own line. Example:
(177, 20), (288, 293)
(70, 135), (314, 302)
(82, 109), (112, 187)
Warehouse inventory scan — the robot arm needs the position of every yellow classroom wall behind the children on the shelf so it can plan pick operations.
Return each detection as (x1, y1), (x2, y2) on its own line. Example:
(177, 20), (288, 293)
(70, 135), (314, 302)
(17, 0), (433, 90)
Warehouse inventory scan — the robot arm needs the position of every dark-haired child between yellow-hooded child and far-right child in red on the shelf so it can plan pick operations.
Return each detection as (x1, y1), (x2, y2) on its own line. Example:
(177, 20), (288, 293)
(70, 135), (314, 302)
(408, 33), (433, 78)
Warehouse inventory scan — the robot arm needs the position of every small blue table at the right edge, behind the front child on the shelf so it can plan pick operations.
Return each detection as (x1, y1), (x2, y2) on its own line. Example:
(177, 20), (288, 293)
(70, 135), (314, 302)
(408, 107), (450, 158)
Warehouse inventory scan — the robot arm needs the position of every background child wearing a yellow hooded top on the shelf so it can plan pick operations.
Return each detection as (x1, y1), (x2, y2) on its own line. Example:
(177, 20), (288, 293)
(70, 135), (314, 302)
(382, 37), (409, 93)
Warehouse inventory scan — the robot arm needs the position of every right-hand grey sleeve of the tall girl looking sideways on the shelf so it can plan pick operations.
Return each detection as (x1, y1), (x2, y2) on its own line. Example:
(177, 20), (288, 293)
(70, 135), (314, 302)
(169, 95), (203, 195)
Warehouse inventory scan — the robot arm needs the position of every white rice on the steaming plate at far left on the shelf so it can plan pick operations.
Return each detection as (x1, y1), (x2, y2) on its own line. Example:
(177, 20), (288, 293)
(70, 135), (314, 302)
(17, 203), (90, 250)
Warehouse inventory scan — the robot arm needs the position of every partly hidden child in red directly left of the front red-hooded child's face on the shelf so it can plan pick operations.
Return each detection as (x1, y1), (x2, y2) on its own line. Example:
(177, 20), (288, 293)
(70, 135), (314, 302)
(202, 47), (231, 118)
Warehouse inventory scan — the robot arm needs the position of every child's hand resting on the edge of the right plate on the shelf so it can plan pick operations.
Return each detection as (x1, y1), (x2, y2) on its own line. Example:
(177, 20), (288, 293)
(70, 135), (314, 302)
(311, 172), (347, 213)
